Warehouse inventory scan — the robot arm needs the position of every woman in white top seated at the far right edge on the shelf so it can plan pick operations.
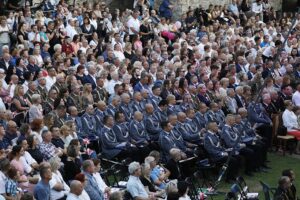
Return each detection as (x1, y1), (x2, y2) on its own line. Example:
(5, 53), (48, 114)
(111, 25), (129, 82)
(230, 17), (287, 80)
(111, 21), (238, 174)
(282, 100), (300, 154)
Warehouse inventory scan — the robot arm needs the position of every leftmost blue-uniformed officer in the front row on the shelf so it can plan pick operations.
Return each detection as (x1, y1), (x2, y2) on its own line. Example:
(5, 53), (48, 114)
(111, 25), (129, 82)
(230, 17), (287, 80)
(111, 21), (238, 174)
(100, 115), (141, 162)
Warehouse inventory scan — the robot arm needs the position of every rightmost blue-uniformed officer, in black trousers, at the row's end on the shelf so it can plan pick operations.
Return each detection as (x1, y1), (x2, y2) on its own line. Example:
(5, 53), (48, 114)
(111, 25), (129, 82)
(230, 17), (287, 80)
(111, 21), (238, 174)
(248, 102), (273, 148)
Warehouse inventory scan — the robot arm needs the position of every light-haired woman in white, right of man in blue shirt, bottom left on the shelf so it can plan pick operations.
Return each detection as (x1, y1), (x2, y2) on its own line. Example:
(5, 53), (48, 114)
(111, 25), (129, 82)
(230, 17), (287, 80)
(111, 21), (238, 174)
(49, 156), (70, 200)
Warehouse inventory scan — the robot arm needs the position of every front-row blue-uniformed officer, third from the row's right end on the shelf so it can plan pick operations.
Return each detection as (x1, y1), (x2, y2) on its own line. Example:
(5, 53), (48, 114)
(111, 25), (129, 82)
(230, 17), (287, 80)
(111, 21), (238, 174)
(221, 114), (256, 176)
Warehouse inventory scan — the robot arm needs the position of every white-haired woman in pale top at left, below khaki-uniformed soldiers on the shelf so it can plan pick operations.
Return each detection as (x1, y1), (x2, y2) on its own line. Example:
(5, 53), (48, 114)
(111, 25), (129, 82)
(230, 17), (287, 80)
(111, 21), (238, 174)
(29, 94), (43, 123)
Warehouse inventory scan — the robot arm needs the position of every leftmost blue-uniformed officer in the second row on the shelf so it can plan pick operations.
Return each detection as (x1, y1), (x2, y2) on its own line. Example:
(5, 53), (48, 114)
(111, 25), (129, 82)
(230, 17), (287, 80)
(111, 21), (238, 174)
(81, 104), (100, 141)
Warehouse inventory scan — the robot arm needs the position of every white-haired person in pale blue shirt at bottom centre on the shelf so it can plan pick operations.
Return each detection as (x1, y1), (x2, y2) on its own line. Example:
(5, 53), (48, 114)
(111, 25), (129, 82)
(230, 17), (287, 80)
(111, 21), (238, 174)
(126, 162), (155, 200)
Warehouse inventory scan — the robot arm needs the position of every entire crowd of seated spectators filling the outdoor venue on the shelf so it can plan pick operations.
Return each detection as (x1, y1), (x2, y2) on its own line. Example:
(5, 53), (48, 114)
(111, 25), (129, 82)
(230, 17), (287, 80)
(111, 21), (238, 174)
(0, 0), (300, 200)
